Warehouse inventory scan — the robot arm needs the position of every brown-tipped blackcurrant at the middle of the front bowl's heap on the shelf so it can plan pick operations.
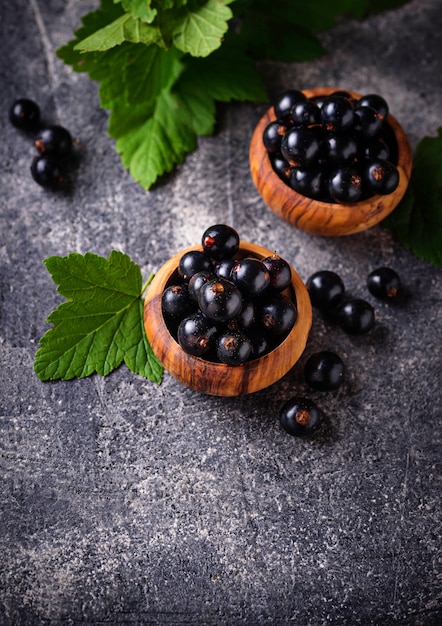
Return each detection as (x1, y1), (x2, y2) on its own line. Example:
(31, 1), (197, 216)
(198, 277), (243, 322)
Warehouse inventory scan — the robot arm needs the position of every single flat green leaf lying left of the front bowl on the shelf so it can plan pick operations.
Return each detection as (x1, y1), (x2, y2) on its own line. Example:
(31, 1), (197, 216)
(34, 250), (162, 382)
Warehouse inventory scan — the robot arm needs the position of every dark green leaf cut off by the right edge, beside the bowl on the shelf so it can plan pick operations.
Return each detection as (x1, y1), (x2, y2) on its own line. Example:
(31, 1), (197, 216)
(382, 127), (442, 266)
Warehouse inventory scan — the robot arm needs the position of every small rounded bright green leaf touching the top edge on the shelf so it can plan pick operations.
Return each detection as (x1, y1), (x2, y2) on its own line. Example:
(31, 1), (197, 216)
(172, 0), (233, 57)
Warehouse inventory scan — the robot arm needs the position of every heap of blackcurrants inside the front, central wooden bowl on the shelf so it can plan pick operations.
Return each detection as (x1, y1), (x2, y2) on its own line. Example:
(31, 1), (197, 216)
(162, 224), (297, 365)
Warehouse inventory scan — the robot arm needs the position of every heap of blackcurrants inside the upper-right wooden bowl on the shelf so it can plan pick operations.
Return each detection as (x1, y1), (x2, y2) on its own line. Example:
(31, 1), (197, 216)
(263, 89), (399, 204)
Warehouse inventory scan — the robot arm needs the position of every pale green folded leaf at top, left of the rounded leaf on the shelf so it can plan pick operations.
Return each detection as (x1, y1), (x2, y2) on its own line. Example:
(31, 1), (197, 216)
(74, 14), (165, 52)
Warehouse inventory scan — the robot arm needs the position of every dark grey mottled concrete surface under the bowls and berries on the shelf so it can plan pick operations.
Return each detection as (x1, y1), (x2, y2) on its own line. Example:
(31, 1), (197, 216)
(0, 0), (442, 626)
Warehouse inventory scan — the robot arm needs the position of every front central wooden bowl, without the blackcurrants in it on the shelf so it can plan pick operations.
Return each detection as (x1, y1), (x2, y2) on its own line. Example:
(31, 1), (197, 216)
(144, 241), (312, 396)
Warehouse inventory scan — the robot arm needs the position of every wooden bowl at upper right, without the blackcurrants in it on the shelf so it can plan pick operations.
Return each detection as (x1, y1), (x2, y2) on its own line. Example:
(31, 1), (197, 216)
(249, 87), (412, 236)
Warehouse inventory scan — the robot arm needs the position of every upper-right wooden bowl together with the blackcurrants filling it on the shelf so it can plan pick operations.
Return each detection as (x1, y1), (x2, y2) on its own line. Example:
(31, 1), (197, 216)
(250, 87), (412, 236)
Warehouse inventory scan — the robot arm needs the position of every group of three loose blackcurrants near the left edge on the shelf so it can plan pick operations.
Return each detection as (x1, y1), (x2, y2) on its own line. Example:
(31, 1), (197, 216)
(9, 98), (73, 191)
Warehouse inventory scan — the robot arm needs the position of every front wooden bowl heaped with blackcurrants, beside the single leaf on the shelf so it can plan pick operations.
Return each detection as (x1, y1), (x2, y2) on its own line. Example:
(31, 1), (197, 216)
(144, 224), (312, 396)
